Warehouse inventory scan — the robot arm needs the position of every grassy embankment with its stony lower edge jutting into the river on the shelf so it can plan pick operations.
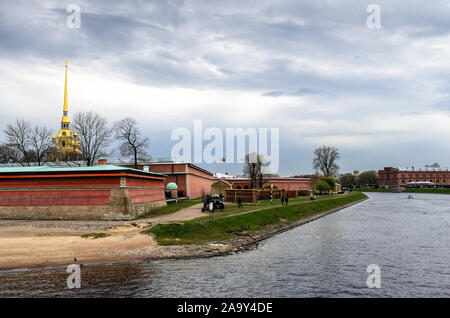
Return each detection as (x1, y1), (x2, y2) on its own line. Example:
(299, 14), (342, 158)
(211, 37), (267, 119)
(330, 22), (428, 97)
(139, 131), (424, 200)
(143, 192), (367, 258)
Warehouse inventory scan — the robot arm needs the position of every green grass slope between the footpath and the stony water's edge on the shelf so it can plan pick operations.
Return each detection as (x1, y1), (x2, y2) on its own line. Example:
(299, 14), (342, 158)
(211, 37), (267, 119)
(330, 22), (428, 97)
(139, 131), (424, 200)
(146, 191), (366, 245)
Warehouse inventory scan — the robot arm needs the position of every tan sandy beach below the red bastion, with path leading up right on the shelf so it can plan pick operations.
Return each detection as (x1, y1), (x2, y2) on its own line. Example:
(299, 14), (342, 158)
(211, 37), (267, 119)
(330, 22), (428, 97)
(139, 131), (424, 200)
(0, 205), (204, 270)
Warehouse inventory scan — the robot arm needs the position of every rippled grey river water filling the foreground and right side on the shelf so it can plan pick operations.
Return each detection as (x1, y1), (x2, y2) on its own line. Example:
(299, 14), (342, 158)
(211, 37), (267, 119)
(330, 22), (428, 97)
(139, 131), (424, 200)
(0, 193), (450, 297)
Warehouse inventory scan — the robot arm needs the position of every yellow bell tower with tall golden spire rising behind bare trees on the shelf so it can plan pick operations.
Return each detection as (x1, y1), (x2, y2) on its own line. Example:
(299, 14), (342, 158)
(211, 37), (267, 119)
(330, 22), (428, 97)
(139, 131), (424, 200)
(53, 60), (80, 159)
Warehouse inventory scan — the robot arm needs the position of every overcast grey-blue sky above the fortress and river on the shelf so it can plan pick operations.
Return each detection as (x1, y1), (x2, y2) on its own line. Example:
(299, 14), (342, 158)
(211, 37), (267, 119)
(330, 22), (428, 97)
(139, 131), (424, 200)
(0, 0), (450, 175)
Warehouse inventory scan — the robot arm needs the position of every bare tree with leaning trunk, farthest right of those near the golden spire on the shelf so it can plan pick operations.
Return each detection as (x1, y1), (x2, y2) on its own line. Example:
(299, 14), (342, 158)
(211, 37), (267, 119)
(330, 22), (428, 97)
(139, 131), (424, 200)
(114, 117), (149, 169)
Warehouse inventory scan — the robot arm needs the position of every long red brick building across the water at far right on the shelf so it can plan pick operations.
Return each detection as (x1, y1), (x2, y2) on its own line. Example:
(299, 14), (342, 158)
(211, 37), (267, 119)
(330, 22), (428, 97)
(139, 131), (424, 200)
(378, 167), (450, 188)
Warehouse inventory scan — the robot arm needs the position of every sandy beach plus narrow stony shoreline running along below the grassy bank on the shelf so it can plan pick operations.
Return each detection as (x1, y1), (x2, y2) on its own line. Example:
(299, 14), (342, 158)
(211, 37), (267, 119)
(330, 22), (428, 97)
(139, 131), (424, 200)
(0, 198), (367, 270)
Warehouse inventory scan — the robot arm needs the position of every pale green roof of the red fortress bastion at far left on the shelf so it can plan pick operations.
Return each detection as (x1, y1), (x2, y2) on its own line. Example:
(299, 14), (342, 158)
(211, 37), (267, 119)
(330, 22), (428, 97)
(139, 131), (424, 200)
(0, 165), (166, 177)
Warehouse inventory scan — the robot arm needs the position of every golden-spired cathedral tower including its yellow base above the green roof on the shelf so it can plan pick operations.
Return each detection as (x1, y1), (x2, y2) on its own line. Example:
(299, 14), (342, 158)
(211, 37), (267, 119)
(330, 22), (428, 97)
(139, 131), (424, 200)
(49, 60), (80, 161)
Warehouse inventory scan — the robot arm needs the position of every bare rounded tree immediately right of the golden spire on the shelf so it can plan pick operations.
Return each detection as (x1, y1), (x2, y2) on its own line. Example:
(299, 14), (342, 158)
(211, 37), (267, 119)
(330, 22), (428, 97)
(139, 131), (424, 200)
(72, 111), (112, 166)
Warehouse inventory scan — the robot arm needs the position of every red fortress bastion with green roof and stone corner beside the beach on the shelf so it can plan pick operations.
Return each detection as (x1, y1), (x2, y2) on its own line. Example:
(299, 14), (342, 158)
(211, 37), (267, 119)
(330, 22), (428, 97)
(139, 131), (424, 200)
(0, 165), (166, 220)
